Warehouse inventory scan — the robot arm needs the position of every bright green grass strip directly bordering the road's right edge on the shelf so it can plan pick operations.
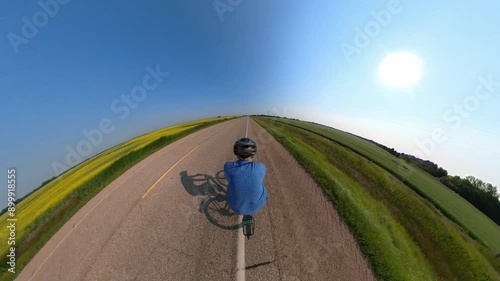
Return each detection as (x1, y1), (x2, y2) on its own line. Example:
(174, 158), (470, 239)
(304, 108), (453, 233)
(256, 118), (435, 280)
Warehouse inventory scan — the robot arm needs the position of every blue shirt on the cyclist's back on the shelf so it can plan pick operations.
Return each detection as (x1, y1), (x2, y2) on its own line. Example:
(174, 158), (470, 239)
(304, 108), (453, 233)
(224, 160), (267, 215)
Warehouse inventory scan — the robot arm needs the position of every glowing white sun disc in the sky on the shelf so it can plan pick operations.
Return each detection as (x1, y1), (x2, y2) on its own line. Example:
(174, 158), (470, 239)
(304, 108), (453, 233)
(378, 53), (422, 88)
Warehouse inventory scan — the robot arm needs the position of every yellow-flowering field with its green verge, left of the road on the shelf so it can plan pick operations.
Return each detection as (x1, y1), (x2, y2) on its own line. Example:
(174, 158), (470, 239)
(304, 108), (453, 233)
(0, 117), (232, 280)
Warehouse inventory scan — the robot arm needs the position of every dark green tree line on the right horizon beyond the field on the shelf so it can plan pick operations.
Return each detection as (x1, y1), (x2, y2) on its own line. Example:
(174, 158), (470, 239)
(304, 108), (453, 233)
(376, 140), (500, 225)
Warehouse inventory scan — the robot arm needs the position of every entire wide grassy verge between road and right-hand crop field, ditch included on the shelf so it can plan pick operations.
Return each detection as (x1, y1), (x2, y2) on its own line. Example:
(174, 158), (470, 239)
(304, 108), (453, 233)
(255, 118), (500, 280)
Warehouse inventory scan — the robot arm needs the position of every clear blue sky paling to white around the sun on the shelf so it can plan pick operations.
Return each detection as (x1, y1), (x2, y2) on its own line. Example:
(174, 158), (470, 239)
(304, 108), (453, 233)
(0, 0), (500, 201)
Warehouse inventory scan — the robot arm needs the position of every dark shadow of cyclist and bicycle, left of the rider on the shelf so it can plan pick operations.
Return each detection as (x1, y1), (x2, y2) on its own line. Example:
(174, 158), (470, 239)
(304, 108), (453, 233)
(179, 170), (241, 230)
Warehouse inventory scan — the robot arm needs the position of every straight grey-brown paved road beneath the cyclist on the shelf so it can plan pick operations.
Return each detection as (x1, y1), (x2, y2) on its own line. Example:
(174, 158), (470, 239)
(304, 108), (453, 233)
(17, 117), (374, 281)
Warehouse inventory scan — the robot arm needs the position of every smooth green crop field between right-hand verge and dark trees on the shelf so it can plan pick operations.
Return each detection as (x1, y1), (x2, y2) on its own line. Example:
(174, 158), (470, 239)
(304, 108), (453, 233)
(277, 116), (500, 253)
